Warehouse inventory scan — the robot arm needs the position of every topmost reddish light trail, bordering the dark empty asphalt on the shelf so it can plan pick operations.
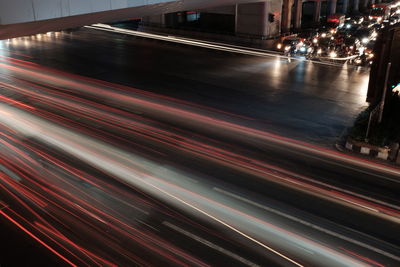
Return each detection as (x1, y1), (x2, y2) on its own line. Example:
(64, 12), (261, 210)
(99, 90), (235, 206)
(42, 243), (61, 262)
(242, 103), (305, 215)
(0, 58), (400, 183)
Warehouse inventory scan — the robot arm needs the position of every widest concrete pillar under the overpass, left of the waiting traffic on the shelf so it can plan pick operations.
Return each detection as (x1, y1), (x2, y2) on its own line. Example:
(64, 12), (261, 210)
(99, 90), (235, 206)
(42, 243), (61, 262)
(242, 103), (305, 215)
(236, 0), (282, 36)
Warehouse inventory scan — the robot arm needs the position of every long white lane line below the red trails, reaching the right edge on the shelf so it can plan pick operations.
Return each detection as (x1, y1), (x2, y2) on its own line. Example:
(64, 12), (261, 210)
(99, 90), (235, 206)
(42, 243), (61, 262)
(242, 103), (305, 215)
(213, 187), (400, 261)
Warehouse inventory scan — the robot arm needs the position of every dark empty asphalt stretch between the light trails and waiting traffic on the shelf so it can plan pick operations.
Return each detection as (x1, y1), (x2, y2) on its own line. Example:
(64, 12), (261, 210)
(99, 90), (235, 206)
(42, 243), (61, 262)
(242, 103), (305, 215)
(0, 25), (369, 145)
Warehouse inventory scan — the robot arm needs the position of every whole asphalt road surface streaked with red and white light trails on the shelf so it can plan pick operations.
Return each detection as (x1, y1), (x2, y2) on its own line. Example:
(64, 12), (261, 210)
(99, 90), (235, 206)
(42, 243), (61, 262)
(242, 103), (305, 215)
(0, 29), (400, 266)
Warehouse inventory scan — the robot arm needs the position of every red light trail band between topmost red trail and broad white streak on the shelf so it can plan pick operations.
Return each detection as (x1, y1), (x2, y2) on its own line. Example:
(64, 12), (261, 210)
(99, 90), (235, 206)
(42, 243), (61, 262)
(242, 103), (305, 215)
(0, 71), (399, 224)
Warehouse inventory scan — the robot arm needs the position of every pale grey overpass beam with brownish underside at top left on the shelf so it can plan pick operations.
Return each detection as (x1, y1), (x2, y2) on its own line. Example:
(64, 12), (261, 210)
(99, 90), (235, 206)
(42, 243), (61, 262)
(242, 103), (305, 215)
(0, 0), (262, 39)
